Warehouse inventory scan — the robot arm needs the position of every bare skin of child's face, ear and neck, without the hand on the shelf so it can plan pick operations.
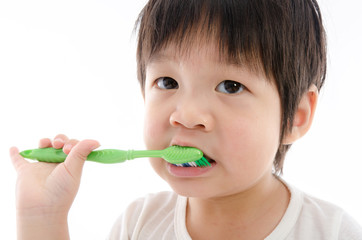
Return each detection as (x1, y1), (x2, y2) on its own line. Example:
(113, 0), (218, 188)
(145, 41), (317, 239)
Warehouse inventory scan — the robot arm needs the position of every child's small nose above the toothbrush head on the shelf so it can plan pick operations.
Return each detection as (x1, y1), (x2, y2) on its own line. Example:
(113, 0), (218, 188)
(170, 99), (215, 132)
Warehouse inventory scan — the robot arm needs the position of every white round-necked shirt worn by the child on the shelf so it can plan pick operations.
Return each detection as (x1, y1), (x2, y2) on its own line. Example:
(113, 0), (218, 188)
(109, 185), (362, 240)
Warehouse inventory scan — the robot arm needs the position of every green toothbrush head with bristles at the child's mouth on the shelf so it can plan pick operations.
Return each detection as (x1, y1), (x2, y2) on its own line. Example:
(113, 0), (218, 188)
(162, 146), (211, 167)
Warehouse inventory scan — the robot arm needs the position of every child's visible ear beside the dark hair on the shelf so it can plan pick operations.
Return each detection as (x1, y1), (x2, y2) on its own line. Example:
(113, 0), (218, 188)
(282, 84), (318, 145)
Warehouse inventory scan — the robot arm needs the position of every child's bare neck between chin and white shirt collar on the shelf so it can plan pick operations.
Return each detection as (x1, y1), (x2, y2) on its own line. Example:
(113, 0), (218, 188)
(186, 175), (290, 239)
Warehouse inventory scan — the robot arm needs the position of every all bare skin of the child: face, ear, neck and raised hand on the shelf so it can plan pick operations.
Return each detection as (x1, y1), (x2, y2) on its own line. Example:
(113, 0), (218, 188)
(11, 40), (318, 239)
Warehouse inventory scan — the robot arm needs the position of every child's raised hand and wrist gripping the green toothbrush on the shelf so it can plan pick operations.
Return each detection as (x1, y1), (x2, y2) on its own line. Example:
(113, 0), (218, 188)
(10, 135), (99, 239)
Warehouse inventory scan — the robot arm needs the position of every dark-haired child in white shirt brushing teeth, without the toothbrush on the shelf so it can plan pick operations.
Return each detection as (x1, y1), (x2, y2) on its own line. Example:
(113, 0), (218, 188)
(11, 0), (362, 240)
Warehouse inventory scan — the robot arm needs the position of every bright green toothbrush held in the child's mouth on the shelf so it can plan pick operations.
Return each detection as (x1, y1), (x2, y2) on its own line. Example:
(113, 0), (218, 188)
(20, 146), (211, 167)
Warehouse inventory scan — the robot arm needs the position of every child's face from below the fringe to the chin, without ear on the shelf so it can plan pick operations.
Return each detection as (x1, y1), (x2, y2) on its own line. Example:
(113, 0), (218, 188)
(144, 41), (281, 198)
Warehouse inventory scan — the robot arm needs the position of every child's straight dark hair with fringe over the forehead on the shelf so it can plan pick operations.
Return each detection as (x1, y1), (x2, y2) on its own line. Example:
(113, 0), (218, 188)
(136, 0), (326, 174)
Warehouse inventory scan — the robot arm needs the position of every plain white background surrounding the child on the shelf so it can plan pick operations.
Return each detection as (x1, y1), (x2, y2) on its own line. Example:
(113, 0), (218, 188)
(0, 0), (362, 239)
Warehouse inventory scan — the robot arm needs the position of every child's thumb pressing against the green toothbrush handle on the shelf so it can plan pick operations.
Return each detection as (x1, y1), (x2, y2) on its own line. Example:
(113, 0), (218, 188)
(64, 140), (99, 179)
